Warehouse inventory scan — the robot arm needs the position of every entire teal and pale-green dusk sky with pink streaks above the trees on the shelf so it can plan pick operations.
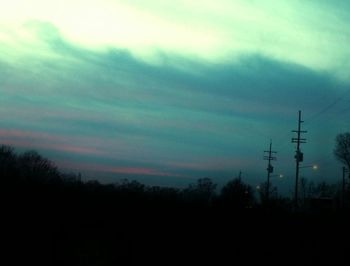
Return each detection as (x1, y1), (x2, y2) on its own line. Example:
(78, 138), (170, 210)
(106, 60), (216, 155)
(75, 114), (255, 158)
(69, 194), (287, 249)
(0, 0), (350, 195)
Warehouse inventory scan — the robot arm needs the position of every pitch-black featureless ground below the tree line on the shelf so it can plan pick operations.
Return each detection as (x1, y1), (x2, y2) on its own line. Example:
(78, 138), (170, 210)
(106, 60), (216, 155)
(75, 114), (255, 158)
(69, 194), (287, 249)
(1, 188), (350, 265)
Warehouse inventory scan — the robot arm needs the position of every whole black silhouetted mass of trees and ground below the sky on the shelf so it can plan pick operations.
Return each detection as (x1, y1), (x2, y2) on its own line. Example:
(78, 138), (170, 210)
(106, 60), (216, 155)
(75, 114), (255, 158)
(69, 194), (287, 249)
(0, 138), (350, 266)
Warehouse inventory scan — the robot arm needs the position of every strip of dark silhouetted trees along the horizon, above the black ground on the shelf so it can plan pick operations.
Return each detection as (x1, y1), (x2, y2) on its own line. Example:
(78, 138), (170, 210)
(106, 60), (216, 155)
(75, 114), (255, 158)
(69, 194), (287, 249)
(0, 133), (350, 213)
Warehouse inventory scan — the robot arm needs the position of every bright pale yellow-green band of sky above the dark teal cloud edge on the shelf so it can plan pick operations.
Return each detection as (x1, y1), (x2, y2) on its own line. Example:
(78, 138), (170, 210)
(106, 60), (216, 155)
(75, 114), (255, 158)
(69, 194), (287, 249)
(0, 0), (350, 79)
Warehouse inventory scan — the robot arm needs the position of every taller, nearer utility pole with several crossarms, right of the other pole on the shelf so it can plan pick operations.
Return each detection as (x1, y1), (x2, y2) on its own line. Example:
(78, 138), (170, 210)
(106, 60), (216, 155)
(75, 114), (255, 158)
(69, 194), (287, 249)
(292, 111), (307, 209)
